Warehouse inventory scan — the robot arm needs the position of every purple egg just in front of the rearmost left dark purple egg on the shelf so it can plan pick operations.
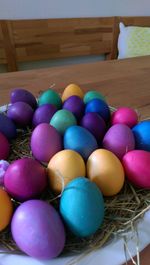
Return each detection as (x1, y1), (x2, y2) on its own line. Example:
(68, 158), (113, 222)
(7, 101), (33, 127)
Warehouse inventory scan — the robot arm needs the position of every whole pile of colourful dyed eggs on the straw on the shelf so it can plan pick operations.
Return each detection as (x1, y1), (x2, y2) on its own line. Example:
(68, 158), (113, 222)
(0, 84), (150, 259)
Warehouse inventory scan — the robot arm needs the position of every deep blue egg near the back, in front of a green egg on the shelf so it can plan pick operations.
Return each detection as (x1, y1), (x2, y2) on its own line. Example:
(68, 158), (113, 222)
(85, 98), (110, 122)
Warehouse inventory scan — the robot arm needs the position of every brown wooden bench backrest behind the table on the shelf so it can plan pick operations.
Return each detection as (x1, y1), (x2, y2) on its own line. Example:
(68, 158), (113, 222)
(0, 17), (150, 71)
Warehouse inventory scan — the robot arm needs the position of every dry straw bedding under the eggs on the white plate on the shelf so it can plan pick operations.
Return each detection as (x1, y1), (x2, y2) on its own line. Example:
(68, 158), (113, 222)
(0, 108), (150, 265)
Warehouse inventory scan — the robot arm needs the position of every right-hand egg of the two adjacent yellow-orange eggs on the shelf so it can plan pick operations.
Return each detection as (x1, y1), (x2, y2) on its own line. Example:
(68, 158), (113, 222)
(87, 149), (125, 196)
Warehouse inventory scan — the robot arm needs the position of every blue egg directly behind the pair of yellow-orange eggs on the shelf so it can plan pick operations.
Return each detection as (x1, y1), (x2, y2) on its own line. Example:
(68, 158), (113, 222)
(64, 125), (98, 160)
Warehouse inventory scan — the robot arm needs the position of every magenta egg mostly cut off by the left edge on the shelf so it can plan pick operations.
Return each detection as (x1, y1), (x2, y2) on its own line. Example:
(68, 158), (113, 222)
(0, 132), (10, 159)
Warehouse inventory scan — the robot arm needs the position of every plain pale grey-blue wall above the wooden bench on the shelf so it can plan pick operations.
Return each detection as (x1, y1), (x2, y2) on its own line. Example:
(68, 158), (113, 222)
(0, 0), (150, 19)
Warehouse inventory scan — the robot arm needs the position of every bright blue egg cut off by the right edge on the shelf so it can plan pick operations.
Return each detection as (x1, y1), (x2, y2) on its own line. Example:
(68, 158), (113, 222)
(132, 120), (150, 151)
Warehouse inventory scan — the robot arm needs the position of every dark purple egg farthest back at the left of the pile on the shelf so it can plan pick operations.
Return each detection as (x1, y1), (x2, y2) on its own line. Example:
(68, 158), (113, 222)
(10, 88), (37, 109)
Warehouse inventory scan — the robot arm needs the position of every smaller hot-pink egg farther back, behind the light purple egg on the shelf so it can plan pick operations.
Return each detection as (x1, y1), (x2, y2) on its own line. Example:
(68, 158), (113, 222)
(111, 107), (138, 128)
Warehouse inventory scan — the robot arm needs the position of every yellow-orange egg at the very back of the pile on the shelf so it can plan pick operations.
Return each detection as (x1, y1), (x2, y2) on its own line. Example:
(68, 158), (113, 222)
(62, 84), (84, 101)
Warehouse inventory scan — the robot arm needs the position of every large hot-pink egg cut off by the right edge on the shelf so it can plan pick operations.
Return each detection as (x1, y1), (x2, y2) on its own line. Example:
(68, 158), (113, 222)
(122, 150), (150, 189)
